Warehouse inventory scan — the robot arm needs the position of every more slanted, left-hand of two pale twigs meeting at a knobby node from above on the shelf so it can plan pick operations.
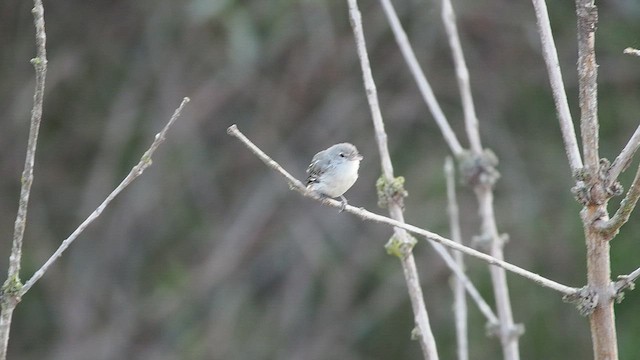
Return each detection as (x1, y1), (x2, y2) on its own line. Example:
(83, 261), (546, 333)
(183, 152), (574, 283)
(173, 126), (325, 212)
(380, 0), (464, 157)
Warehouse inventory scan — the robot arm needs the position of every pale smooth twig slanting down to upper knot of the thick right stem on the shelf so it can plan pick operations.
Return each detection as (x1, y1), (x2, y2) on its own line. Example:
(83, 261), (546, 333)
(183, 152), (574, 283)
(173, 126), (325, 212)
(533, 0), (582, 173)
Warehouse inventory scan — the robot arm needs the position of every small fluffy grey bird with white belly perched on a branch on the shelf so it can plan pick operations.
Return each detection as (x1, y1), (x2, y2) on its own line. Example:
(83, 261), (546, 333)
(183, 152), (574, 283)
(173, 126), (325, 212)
(306, 143), (362, 210)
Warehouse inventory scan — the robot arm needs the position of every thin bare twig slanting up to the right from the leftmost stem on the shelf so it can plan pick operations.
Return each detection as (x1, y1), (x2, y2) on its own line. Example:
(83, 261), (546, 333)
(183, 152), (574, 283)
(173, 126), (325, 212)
(20, 98), (190, 296)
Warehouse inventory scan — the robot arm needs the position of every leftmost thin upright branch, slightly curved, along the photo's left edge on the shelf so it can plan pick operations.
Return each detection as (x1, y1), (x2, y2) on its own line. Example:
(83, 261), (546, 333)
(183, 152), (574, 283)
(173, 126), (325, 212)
(0, 0), (47, 360)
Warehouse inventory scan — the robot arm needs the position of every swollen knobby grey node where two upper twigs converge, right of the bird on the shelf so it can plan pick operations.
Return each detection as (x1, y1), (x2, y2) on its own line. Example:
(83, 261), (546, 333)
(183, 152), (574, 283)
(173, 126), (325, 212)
(458, 149), (500, 187)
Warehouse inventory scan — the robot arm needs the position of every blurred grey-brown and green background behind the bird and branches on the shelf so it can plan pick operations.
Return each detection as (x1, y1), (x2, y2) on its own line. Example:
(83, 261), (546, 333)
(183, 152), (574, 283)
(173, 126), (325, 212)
(0, 0), (640, 360)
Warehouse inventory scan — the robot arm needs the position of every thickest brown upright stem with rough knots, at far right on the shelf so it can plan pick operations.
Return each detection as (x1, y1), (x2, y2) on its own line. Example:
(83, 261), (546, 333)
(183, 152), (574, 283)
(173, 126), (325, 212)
(576, 0), (618, 360)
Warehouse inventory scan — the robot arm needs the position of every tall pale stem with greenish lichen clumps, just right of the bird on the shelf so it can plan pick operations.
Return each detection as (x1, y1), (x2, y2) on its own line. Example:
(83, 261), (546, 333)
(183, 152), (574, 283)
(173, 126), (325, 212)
(349, 0), (438, 360)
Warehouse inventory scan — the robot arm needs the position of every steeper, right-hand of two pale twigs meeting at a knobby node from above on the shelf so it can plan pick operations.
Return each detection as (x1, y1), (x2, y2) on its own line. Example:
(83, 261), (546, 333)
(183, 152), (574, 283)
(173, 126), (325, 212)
(442, 0), (482, 154)
